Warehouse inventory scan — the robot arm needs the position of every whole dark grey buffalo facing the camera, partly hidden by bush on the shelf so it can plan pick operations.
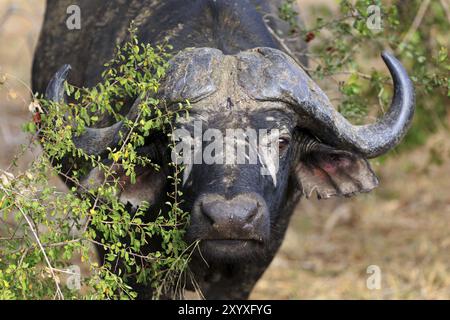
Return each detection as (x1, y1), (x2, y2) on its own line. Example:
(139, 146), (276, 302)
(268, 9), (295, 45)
(33, 0), (414, 299)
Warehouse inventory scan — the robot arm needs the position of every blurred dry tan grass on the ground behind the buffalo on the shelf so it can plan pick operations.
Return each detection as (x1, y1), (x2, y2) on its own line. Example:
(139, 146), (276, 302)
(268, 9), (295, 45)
(0, 0), (450, 299)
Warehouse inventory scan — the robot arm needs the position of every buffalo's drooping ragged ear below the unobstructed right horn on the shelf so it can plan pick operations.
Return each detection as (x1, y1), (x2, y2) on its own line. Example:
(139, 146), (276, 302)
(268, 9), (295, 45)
(296, 144), (378, 199)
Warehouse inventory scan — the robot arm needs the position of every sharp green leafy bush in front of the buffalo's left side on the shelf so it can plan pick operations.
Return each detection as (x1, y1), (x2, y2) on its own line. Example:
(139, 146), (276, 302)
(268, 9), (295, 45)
(0, 28), (192, 299)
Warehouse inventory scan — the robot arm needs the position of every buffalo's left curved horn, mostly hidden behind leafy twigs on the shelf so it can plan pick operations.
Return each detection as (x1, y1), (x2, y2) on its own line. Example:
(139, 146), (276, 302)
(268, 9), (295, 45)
(45, 64), (130, 155)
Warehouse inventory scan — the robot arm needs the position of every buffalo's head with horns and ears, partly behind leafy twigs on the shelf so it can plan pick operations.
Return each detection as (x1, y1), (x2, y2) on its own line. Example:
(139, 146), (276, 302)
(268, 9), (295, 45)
(47, 48), (414, 260)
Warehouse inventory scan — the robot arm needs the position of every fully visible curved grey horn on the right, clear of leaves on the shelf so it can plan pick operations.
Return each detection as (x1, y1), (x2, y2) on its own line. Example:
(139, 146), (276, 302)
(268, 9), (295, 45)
(239, 48), (415, 158)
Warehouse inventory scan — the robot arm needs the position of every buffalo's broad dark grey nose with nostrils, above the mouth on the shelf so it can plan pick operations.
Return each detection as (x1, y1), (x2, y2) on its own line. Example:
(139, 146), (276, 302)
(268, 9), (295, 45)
(201, 197), (264, 240)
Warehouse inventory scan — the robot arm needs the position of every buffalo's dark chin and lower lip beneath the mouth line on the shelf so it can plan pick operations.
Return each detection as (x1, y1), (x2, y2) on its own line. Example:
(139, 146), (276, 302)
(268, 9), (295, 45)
(200, 239), (264, 262)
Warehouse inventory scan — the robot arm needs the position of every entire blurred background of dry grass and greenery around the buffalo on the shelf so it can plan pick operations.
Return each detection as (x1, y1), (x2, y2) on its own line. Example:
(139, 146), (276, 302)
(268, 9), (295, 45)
(0, 0), (450, 299)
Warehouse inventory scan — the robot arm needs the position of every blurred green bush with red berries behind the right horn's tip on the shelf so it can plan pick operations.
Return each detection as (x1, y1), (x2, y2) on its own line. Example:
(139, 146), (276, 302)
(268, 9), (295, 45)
(280, 0), (450, 150)
